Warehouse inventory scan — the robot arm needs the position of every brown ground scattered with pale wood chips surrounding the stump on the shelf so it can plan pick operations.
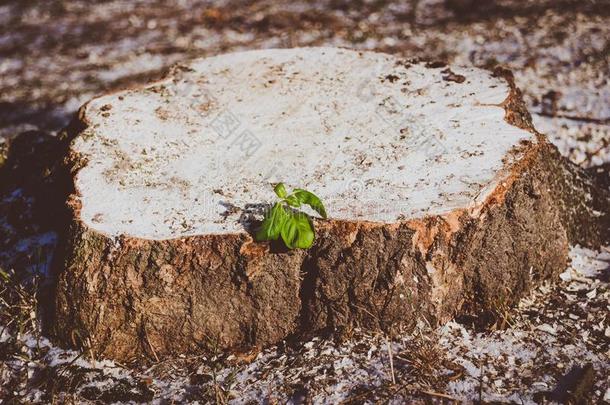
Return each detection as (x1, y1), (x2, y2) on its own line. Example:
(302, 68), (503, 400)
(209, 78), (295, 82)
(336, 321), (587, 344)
(0, 0), (610, 403)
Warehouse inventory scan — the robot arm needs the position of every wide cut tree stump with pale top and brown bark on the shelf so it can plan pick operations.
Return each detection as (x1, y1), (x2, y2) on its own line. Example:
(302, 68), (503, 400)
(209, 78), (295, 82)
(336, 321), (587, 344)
(55, 48), (604, 361)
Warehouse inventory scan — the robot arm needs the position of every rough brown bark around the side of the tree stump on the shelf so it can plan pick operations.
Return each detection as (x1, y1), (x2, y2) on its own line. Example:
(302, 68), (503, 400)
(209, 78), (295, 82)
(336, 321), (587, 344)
(50, 52), (608, 361)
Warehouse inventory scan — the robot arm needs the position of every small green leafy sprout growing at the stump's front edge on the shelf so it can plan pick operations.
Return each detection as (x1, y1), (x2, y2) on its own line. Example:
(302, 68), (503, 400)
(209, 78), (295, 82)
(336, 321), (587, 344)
(256, 183), (326, 249)
